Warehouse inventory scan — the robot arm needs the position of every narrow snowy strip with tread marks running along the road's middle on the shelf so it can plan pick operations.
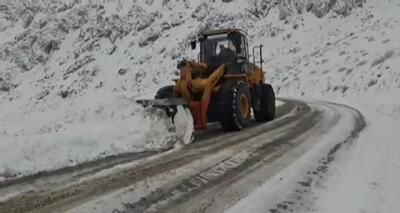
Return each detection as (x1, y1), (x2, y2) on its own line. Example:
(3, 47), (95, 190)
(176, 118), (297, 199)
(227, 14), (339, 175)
(119, 106), (320, 213)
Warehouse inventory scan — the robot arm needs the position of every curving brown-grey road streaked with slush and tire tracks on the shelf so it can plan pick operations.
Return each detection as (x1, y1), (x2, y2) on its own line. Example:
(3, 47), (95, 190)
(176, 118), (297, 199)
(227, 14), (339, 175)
(0, 100), (365, 212)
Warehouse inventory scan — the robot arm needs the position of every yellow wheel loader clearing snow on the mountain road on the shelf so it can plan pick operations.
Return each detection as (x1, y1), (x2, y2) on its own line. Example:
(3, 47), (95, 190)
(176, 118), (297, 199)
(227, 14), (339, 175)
(139, 29), (275, 131)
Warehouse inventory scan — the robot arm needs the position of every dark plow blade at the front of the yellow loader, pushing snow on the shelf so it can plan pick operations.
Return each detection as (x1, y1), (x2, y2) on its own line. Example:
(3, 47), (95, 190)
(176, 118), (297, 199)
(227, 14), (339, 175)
(136, 98), (189, 122)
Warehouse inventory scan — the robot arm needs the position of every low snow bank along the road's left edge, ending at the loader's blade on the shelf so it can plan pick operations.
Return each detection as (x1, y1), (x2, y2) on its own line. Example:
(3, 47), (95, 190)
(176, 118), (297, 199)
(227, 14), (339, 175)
(0, 94), (193, 180)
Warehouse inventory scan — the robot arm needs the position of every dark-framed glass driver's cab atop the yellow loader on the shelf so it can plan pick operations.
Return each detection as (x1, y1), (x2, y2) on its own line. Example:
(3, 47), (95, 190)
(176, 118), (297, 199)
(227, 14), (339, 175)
(191, 29), (249, 73)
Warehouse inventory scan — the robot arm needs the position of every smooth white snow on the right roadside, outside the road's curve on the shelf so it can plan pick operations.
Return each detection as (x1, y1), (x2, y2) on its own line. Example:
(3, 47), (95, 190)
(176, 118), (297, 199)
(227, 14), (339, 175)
(310, 90), (400, 213)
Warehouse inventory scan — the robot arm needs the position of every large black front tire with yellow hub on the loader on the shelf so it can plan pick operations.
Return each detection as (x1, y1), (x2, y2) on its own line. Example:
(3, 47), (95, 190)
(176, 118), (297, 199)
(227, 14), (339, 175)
(219, 81), (251, 131)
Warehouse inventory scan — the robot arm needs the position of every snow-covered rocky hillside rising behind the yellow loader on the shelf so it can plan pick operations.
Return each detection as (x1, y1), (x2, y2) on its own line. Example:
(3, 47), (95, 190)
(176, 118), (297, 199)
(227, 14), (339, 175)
(0, 0), (400, 206)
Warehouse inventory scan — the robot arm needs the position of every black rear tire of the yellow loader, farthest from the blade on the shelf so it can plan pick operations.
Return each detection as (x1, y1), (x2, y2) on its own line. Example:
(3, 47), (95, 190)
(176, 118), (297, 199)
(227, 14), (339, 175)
(254, 83), (275, 122)
